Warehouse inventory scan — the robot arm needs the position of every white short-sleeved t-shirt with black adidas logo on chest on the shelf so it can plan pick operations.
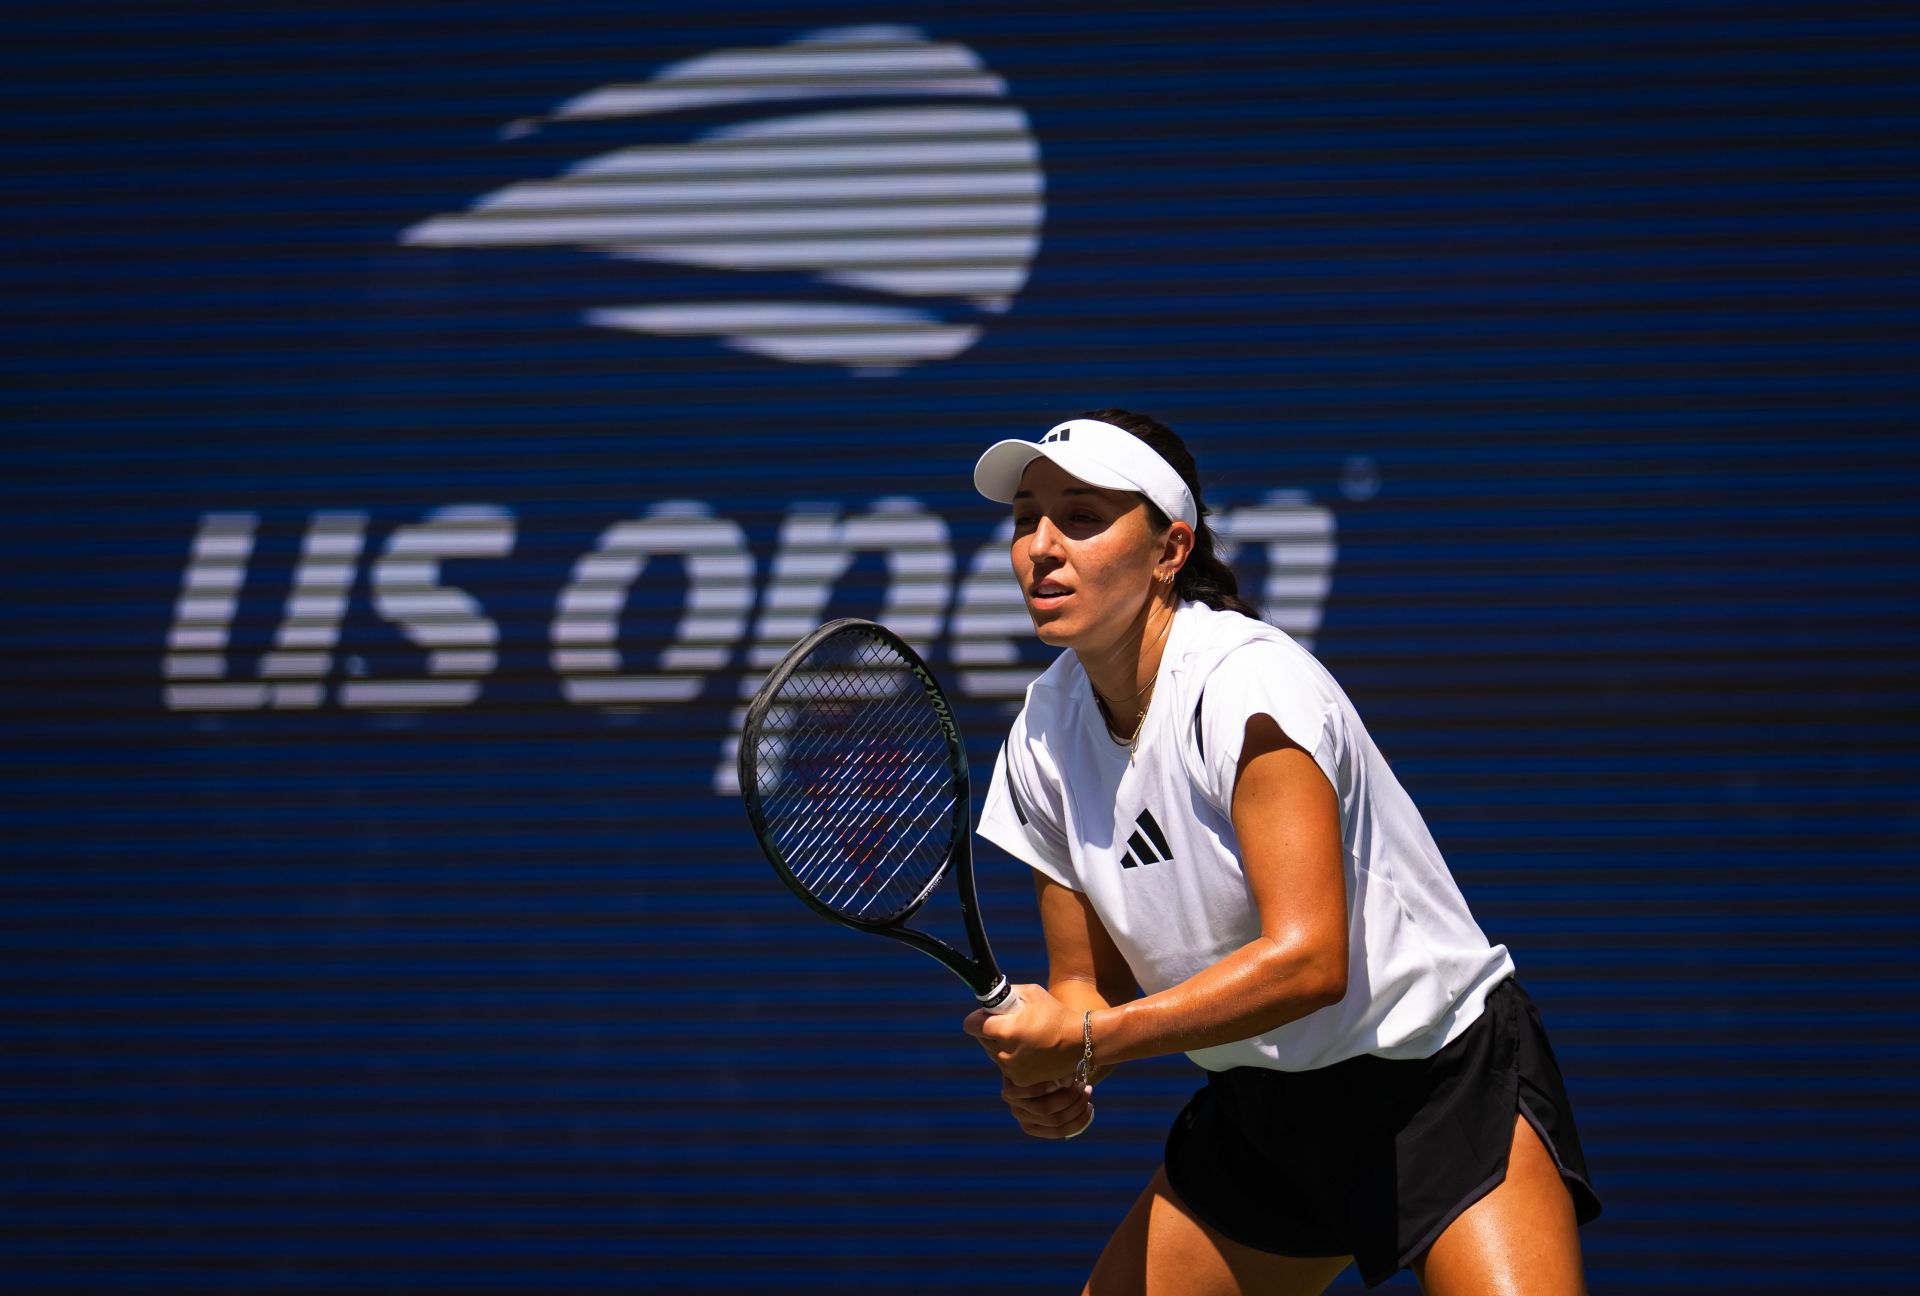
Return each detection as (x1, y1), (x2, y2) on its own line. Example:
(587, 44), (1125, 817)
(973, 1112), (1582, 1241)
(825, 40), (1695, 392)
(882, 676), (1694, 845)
(979, 603), (1513, 1071)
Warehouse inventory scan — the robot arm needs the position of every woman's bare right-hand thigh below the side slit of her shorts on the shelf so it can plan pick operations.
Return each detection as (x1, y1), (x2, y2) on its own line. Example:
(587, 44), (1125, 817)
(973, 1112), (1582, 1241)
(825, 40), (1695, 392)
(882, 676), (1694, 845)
(1413, 1116), (1586, 1296)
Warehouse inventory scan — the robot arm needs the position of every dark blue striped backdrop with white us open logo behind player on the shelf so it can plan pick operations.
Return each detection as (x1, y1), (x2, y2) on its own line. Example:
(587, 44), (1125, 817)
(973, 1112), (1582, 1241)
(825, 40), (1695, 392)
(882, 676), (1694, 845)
(0, 0), (1920, 1292)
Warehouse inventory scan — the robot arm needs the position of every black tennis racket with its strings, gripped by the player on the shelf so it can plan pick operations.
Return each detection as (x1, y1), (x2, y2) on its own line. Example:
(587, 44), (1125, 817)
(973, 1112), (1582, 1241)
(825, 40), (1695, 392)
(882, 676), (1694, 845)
(739, 618), (1020, 1012)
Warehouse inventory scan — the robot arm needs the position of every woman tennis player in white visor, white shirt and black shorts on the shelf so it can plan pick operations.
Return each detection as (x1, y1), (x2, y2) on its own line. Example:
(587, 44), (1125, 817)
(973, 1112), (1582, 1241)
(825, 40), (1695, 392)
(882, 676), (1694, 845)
(966, 409), (1599, 1296)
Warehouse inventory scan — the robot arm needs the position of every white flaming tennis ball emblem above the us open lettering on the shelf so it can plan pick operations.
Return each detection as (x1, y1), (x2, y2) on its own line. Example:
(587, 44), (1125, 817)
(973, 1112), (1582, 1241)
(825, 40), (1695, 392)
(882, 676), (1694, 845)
(399, 27), (1044, 376)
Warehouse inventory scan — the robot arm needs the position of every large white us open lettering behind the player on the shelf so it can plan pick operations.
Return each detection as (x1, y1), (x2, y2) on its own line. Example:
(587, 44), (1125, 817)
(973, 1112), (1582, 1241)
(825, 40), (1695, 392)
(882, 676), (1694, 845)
(161, 492), (1338, 791)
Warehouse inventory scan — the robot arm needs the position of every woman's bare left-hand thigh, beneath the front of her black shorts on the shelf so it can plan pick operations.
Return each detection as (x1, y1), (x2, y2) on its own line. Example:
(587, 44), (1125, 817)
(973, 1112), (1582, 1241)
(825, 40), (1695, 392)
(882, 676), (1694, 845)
(1081, 1165), (1352, 1296)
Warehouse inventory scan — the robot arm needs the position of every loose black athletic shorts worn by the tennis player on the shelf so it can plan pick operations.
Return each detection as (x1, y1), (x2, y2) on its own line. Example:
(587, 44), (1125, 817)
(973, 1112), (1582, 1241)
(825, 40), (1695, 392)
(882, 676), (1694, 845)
(1167, 979), (1599, 1286)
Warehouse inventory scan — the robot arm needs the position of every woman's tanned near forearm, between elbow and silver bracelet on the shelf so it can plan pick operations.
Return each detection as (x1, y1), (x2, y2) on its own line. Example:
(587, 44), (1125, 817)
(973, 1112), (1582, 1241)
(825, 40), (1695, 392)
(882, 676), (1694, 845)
(1090, 937), (1346, 1068)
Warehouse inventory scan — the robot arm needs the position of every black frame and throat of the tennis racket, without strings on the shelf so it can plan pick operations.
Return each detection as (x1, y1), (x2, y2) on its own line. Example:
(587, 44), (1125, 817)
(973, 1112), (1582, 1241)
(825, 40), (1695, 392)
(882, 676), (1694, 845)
(739, 616), (1012, 1008)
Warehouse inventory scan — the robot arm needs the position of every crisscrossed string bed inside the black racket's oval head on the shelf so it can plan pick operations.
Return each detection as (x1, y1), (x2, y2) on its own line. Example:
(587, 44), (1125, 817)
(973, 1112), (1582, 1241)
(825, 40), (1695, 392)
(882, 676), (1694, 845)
(755, 632), (954, 922)
